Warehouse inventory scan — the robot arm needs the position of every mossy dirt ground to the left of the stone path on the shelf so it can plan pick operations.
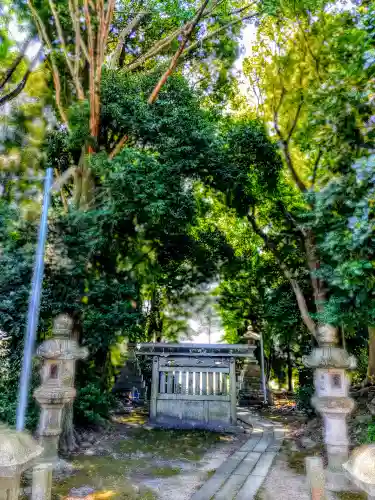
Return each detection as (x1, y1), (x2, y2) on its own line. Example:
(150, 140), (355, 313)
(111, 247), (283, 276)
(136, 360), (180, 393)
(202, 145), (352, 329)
(47, 412), (249, 500)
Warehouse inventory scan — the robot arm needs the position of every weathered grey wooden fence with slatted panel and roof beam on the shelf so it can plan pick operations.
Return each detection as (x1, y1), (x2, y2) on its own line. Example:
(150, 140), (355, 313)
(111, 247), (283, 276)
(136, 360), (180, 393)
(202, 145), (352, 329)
(138, 344), (255, 429)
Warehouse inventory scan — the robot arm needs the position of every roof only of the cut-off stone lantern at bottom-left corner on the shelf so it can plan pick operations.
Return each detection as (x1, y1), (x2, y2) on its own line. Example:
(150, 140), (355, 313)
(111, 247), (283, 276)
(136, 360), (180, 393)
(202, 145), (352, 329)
(0, 424), (43, 478)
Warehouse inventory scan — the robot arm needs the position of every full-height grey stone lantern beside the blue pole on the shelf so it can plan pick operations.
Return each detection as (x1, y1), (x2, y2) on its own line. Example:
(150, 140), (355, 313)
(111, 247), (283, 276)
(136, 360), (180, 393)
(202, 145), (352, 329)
(34, 314), (88, 463)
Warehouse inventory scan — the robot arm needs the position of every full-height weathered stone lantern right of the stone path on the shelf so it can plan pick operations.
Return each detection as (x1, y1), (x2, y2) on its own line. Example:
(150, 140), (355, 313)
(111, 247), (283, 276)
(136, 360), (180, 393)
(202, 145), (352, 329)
(304, 325), (356, 491)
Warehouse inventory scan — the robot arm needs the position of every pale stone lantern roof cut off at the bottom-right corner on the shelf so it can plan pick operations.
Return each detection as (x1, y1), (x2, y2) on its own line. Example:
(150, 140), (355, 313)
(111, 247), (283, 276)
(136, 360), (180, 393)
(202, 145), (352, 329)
(343, 444), (375, 496)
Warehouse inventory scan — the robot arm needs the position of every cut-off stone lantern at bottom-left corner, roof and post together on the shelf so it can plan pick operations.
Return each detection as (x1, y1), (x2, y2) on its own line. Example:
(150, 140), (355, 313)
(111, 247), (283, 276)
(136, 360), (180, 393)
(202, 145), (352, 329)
(0, 424), (43, 500)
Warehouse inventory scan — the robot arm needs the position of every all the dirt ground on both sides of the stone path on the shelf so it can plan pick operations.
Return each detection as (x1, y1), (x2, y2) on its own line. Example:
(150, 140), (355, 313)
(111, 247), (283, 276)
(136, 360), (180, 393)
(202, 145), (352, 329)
(24, 402), (372, 500)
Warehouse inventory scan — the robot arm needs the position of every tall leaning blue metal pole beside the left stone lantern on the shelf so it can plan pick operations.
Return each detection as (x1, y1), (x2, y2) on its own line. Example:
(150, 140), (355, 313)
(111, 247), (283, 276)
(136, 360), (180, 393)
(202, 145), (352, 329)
(16, 168), (53, 431)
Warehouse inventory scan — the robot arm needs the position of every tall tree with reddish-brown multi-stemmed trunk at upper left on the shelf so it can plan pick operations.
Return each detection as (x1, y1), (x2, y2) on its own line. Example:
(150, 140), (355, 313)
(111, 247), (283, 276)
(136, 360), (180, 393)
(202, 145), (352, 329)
(28, 0), (255, 208)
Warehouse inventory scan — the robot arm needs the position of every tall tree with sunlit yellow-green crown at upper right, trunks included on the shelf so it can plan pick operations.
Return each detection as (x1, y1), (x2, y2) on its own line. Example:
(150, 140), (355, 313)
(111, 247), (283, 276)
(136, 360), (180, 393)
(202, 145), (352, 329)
(239, 2), (371, 336)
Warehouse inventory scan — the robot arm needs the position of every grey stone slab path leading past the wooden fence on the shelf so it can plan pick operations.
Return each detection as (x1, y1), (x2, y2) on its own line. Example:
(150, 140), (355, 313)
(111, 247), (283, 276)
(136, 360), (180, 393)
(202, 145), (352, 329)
(191, 409), (284, 500)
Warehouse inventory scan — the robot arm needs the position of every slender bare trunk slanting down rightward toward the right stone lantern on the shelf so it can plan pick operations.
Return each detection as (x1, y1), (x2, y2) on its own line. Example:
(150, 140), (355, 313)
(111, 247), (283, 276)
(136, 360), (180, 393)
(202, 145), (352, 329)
(247, 209), (316, 338)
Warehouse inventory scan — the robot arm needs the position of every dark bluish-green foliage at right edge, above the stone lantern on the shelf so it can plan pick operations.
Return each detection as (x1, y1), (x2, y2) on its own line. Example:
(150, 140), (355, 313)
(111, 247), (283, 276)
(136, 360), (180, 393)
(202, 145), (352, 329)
(307, 155), (375, 328)
